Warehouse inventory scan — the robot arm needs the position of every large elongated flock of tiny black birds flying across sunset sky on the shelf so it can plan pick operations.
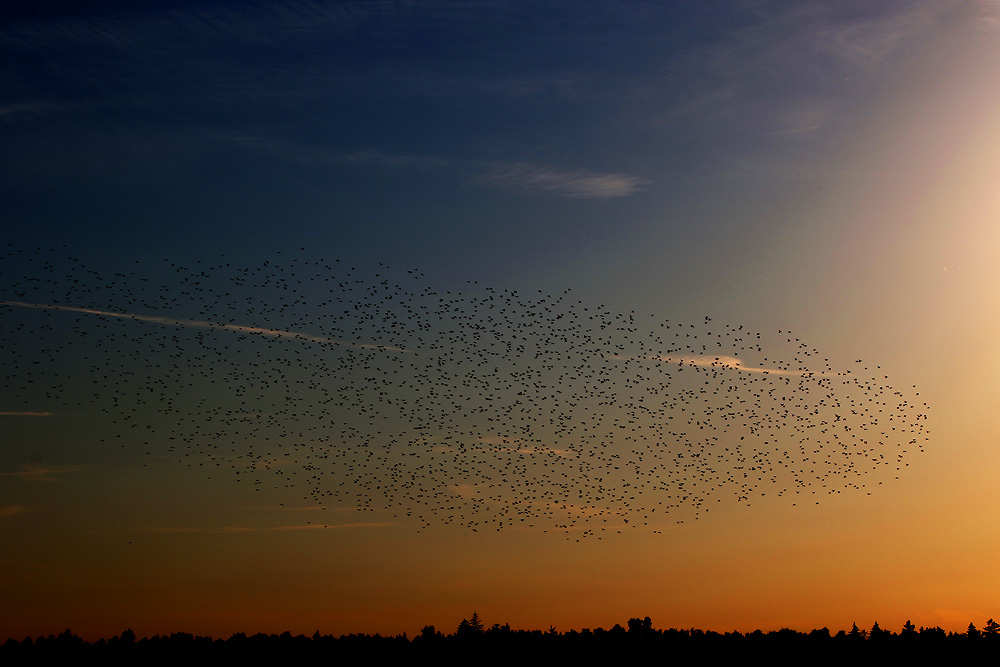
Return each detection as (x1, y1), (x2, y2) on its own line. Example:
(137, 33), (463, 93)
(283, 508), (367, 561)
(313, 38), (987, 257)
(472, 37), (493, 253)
(0, 249), (928, 537)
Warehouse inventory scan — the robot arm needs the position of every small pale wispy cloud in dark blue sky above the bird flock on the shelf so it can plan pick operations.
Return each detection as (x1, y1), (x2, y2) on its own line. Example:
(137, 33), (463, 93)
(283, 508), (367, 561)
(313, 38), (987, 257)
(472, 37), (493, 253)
(473, 162), (648, 199)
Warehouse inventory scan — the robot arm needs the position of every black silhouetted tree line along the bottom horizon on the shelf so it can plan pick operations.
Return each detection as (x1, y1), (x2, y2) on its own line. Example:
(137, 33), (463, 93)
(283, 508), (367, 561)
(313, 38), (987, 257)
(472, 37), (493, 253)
(0, 612), (1000, 659)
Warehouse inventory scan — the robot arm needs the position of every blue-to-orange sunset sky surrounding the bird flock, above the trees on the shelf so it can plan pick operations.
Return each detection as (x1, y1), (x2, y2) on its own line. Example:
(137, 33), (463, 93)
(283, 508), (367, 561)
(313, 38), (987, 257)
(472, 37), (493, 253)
(0, 0), (1000, 638)
